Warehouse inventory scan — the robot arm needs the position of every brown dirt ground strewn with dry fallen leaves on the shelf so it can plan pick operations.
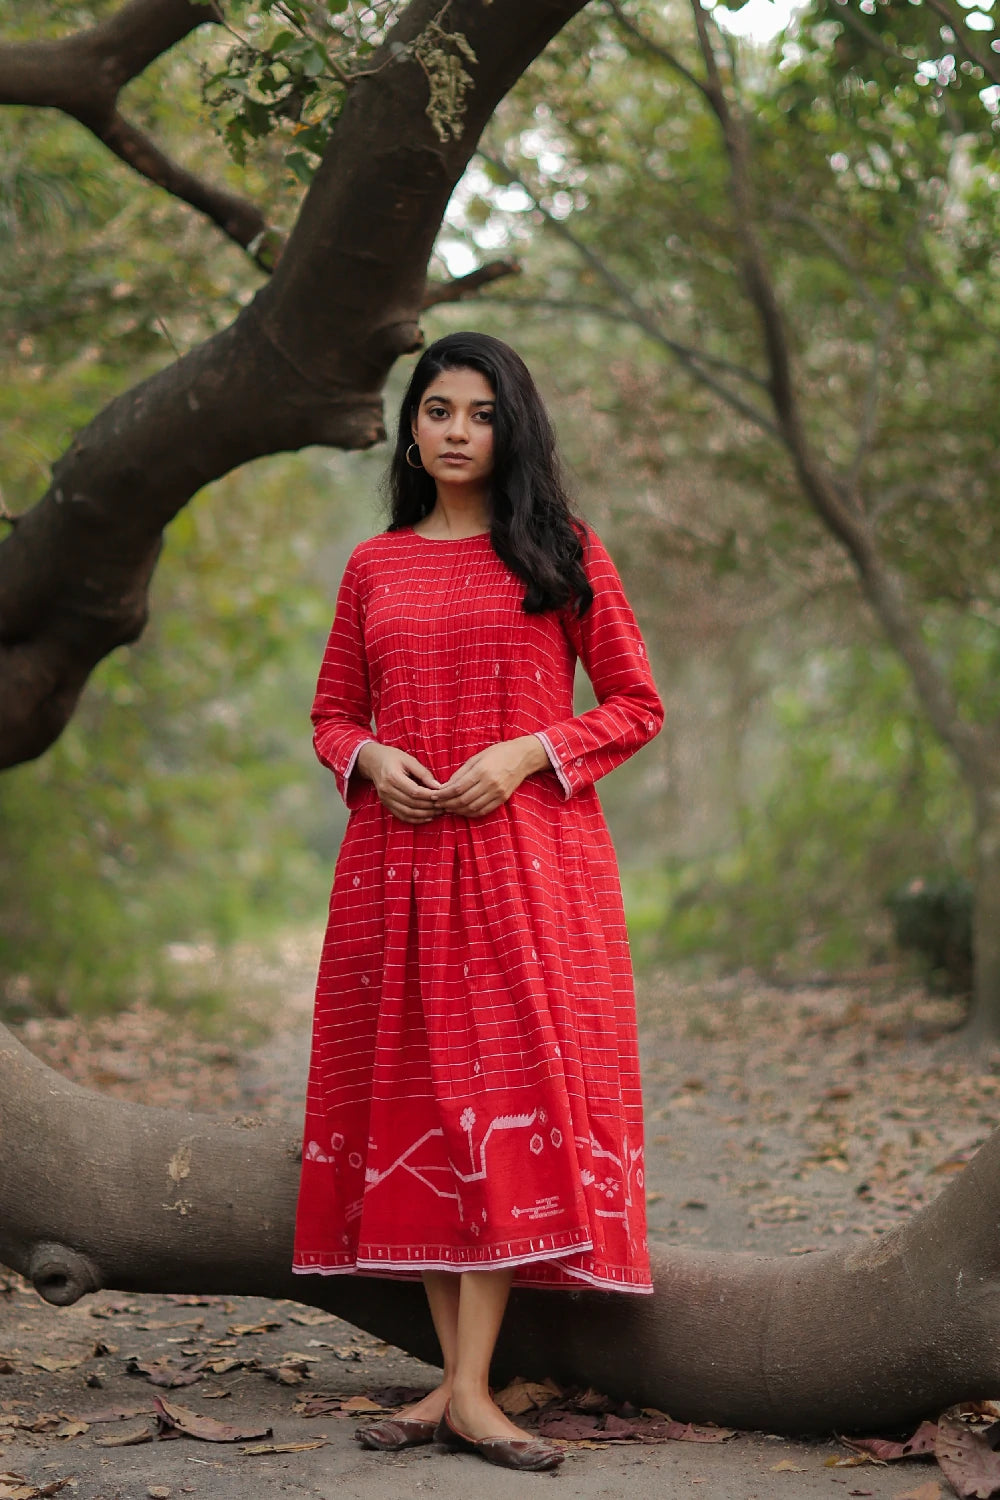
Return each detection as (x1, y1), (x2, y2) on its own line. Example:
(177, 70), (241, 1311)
(0, 938), (1000, 1500)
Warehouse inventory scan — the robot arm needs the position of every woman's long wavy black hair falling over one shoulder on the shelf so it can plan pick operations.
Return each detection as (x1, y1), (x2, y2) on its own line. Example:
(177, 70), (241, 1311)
(385, 333), (594, 615)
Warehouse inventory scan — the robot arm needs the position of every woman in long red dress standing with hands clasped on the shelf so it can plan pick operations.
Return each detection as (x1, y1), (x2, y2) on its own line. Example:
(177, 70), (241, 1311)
(294, 333), (663, 1469)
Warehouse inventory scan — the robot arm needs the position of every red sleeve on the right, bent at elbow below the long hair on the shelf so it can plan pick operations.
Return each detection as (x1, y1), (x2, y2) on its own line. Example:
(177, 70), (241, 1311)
(538, 531), (663, 797)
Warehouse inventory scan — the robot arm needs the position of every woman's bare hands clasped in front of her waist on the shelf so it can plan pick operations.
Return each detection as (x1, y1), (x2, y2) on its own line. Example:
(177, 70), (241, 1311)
(357, 735), (549, 824)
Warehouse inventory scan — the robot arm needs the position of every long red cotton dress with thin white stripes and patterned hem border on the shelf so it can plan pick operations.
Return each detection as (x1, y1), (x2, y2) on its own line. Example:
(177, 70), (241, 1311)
(294, 528), (663, 1292)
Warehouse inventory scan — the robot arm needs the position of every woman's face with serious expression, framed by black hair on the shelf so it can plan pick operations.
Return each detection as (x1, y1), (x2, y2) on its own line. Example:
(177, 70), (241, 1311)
(412, 369), (496, 489)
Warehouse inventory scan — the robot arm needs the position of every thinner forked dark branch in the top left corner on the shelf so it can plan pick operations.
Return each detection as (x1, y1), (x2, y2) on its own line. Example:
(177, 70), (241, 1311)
(0, 0), (283, 272)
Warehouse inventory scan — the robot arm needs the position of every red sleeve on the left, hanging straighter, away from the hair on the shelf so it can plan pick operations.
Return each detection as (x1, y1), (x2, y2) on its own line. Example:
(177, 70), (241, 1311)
(312, 558), (375, 807)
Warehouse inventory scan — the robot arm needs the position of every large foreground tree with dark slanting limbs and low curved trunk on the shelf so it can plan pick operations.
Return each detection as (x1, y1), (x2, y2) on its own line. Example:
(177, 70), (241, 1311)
(0, 0), (1000, 1430)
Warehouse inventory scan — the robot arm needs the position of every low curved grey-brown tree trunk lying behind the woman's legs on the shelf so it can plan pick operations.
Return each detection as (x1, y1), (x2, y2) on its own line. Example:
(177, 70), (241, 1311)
(0, 1028), (1000, 1433)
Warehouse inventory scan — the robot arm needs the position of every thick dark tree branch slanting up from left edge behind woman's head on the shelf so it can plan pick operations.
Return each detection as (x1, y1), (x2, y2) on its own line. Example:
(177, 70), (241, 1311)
(0, 0), (585, 765)
